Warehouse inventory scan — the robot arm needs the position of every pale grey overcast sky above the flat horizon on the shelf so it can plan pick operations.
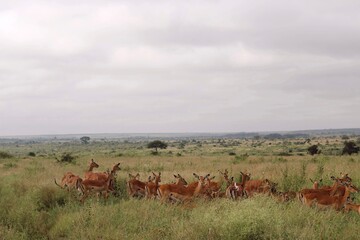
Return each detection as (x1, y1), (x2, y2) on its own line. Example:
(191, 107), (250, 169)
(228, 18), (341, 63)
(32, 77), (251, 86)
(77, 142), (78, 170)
(0, 0), (360, 136)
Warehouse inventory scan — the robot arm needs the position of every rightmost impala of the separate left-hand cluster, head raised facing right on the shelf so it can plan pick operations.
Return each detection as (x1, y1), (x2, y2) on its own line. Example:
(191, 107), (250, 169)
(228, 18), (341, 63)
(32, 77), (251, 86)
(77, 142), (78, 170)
(76, 171), (115, 203)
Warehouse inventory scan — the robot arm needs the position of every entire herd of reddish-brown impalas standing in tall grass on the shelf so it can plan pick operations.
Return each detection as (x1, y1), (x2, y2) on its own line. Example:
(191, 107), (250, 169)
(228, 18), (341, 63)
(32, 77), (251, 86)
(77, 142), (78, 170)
(55, 160), (360, 214)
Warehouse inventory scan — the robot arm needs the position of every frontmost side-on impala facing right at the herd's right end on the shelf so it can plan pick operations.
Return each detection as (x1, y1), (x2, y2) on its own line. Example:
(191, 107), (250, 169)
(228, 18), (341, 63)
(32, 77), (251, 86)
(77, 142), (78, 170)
(302, 182), (359, 210)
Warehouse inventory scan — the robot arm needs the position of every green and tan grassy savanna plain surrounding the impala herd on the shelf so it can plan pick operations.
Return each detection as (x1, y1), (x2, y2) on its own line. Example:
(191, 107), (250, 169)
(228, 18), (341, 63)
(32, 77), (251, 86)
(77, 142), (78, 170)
(0, 137), (360, 239)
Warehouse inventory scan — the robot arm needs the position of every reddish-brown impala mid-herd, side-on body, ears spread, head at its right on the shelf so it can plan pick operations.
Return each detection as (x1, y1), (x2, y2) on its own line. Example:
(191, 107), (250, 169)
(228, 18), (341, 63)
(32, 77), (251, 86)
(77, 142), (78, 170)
(170, 173), (210, 202)
